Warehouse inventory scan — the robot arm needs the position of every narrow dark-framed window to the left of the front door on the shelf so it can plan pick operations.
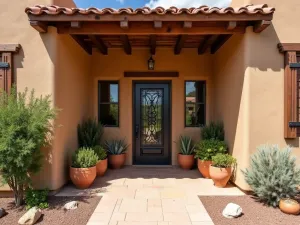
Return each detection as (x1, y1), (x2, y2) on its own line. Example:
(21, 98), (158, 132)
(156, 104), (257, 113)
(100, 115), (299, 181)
(98, 81), (119, 127)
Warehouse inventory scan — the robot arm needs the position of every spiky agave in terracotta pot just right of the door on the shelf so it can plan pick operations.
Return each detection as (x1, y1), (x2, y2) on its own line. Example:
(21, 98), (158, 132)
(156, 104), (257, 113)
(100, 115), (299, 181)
(177, 136), (195, 170)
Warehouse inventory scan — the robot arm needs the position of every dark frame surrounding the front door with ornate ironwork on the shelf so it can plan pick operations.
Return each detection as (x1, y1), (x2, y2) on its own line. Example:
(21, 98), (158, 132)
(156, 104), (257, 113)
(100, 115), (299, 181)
(131, 80), (173, 166)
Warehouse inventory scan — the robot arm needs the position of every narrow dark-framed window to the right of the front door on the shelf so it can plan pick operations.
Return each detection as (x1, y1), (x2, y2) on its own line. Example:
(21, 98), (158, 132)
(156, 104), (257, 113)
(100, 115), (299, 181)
(184, 81), (206, 127)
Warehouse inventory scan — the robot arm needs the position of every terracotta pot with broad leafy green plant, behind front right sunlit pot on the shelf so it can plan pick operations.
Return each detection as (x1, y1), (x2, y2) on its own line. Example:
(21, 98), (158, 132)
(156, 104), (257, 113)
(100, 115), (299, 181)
(195, 139), (227, 178)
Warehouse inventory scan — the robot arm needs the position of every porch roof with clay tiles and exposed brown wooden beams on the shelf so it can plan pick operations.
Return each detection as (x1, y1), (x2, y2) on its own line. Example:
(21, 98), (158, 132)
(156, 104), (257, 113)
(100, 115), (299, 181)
(25, 4), (275, 55)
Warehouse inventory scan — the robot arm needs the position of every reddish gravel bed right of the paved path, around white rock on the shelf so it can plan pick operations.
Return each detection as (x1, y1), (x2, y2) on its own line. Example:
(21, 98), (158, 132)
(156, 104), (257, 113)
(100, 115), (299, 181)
(200, 195), (300, 225)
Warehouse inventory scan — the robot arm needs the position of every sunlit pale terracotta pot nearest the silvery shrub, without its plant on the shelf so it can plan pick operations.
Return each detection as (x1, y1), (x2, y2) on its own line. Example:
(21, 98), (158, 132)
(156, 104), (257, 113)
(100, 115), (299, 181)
(209, 165), (232, 187)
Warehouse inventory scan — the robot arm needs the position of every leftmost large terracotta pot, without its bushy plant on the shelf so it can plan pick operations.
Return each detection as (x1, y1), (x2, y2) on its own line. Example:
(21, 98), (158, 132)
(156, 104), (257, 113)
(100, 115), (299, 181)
(70, 166), (96, 189)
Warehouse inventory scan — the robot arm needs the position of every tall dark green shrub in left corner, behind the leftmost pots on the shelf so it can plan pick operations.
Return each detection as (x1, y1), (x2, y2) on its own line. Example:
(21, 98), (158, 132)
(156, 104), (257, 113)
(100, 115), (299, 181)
(77, 119), (103, 148)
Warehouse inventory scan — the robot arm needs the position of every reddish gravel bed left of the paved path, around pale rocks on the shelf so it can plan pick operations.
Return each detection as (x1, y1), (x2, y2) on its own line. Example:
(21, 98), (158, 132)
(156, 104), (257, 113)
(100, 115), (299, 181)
(0, 196), (101, 225)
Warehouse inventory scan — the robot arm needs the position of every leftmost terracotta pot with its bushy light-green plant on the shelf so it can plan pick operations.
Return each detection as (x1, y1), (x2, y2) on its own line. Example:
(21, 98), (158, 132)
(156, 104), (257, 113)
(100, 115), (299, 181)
(70, 148), (98, 189)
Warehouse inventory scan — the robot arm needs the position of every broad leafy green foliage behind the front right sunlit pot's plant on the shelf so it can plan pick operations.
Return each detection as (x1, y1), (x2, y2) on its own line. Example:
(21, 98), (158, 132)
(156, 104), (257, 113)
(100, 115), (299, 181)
(195, 139), (227, 161)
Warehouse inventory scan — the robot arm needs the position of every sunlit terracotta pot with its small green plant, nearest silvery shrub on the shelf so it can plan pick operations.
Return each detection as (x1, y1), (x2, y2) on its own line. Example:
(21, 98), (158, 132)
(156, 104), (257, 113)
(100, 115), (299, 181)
(209, 153), (236, 187)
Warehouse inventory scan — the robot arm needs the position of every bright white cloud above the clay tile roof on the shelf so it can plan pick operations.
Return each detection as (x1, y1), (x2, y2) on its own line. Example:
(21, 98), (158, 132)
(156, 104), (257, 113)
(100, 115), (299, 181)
(146, 0), (231, 8)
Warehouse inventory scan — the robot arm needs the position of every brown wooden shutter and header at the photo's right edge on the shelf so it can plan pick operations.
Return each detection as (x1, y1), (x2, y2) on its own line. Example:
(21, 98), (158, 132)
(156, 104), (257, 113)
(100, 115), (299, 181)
(278, 43), (300, 138)
